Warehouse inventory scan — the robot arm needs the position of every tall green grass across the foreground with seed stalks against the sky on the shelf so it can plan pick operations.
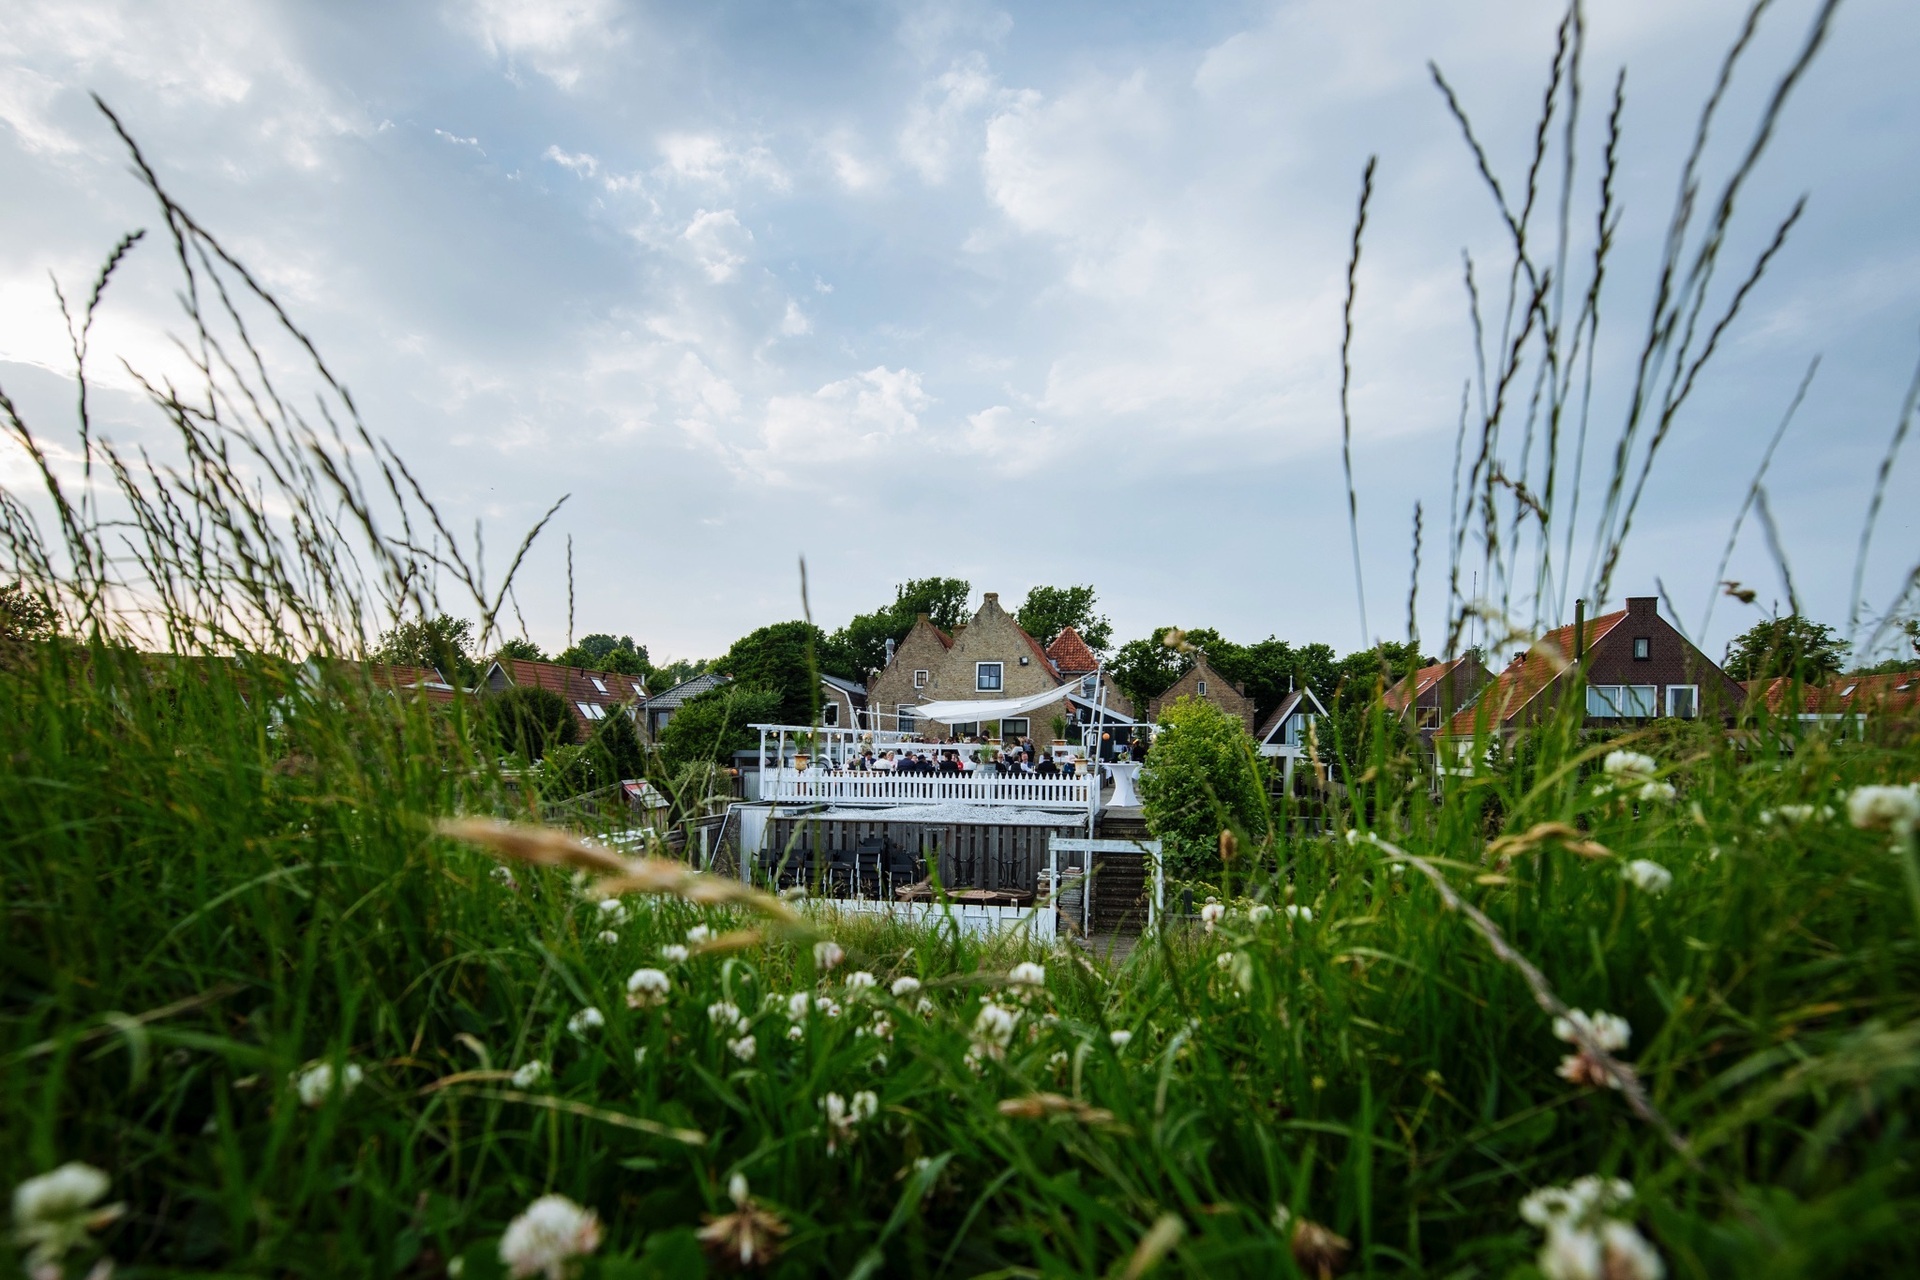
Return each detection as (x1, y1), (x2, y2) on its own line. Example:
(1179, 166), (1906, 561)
(0, 12), (1920, 1280)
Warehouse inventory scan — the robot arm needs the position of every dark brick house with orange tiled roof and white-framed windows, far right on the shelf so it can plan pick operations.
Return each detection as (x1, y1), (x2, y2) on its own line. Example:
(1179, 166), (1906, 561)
(1440, 595), (1745, 743)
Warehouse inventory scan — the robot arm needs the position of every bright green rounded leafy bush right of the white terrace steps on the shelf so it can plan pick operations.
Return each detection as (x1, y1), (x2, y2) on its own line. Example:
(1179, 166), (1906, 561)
(1140, 699), (1267, 875)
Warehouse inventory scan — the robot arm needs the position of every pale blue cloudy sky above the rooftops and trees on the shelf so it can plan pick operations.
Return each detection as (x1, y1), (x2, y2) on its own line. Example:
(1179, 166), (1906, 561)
(0, 0), (1920, 660)
